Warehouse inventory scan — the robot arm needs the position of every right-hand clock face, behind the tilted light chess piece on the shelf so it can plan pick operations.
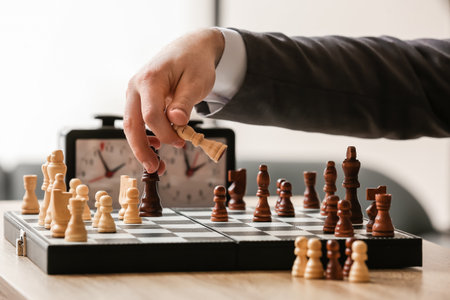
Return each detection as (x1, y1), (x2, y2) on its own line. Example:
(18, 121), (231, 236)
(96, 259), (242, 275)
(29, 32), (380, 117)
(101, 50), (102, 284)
(159, 138), (226, 207)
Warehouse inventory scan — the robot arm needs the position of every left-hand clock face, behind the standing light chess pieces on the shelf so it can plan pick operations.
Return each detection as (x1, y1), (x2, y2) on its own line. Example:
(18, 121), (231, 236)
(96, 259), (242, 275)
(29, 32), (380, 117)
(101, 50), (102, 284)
(75, 139), (142, 208)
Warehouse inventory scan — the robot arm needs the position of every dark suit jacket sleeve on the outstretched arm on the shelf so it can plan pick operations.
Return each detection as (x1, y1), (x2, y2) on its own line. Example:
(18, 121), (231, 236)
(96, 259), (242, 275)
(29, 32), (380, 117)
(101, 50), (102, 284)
(205, 30), (450, 139)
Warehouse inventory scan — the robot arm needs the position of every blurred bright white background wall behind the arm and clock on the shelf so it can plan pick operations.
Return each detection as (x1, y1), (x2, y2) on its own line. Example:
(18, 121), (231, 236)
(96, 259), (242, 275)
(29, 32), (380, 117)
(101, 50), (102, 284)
(0, 0), (450, 231)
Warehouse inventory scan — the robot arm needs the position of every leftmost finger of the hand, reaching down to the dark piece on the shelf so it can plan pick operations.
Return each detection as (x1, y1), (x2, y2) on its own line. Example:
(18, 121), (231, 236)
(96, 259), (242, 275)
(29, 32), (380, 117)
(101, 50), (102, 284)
(123, 89), (160, 173)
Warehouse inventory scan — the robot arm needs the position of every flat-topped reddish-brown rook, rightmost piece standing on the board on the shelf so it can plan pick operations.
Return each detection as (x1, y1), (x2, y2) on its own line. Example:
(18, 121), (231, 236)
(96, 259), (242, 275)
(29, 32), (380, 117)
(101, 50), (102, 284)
(372, 194), (394, 237)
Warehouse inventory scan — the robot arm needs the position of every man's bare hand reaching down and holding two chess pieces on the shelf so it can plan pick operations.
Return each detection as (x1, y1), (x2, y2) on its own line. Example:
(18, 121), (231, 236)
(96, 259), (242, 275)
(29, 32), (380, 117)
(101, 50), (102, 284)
(124, 29), (225, 174)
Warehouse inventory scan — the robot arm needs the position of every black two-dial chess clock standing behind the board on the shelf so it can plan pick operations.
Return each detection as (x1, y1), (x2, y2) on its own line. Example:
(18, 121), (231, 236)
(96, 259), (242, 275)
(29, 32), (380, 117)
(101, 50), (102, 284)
(60, 115), (236, 208)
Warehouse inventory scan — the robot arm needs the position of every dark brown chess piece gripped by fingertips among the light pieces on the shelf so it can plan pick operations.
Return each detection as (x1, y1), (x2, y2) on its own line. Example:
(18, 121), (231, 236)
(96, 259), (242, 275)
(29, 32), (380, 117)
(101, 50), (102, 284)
(139, 169), (162, 217)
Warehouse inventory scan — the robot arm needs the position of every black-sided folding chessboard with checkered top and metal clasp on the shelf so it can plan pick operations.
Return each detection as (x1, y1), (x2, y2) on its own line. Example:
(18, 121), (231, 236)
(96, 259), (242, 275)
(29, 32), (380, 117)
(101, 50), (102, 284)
(4, 208), (422, 274)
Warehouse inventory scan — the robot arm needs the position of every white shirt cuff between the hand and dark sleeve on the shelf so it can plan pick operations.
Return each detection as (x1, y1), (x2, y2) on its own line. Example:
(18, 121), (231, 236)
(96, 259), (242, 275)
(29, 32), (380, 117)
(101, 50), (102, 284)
(197, 27), (247, 117)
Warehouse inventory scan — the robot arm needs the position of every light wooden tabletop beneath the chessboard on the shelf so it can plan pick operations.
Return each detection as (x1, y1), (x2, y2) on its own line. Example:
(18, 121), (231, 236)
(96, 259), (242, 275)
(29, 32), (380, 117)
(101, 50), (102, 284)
(0, 198), (450, 300)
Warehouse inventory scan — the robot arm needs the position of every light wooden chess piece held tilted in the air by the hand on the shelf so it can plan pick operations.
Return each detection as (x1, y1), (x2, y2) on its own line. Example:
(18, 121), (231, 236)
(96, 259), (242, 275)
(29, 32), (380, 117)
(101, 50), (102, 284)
(173, 125), (228, 162)
